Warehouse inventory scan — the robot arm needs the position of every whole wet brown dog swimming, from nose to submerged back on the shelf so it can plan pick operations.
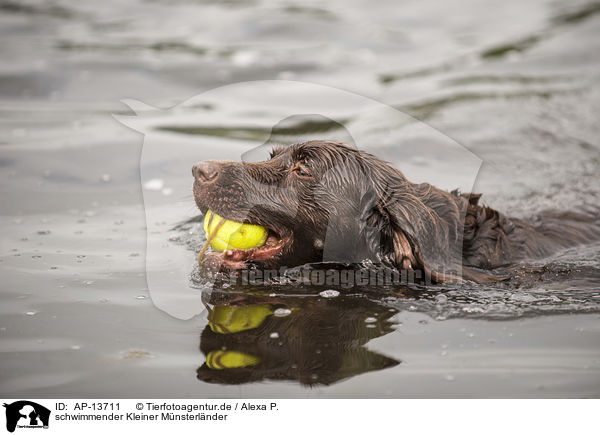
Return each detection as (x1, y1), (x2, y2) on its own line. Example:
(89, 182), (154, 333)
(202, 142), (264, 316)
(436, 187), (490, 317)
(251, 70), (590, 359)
(192, 141), (600, 282)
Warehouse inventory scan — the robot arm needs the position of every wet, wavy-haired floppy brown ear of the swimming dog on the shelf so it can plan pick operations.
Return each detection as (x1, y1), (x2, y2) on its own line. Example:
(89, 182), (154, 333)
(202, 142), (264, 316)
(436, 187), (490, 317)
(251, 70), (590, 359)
(361, 156), (496, 283)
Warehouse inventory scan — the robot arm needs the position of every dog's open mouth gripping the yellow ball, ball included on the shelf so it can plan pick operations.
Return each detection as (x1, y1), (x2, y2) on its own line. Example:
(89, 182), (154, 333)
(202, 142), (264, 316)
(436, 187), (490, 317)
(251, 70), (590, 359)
(198, 210), (289, 270)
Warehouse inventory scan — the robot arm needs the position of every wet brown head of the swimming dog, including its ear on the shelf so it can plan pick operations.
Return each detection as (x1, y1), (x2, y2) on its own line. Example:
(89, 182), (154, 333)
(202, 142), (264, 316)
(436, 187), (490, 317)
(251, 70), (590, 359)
(192, 141), (462, 282)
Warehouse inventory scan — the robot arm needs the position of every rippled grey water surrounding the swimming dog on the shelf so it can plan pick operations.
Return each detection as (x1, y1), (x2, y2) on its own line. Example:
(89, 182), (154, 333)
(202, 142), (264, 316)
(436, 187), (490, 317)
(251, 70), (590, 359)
(0, 0), (600, 398)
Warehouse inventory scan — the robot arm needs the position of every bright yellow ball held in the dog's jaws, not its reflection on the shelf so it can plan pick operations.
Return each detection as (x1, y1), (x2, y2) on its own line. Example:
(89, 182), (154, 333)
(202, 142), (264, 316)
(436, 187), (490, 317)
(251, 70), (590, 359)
(204, 210), (267, 251)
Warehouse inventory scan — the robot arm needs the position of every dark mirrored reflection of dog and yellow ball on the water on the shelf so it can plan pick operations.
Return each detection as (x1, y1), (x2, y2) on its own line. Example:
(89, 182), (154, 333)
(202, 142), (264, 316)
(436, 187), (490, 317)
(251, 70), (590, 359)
(197, 292), (399, 385)
